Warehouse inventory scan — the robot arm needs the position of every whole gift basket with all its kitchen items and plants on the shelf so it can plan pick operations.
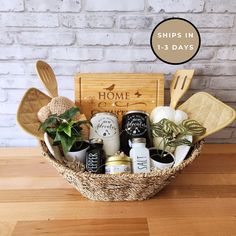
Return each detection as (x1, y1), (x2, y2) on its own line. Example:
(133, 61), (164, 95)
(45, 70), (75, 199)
(17, 61), (235, 201)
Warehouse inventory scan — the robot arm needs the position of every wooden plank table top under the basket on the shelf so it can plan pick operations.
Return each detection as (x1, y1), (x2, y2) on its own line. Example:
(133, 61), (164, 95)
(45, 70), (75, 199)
(0, 144), (236, 236)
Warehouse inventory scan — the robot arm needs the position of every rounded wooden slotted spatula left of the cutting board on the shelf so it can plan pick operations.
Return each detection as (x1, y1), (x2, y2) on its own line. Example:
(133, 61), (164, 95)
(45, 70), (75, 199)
(36, 61), (58, 97)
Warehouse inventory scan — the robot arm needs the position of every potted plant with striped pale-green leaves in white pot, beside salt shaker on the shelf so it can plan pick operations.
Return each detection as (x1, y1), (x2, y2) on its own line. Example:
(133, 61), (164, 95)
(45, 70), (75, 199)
(150, 118), (206, 169)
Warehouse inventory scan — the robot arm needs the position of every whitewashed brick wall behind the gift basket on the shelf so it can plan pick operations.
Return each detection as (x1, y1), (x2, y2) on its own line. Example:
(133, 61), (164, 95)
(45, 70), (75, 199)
(0, 0), (236, 146)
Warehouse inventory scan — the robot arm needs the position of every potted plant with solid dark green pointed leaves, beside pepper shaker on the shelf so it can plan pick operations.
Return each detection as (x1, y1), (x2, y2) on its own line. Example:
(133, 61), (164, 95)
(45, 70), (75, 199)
(39, 107), (90, 163)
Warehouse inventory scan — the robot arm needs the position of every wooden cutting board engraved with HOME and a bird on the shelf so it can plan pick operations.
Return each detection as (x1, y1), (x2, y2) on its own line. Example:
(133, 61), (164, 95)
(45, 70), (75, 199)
(75, 73), (164, 120)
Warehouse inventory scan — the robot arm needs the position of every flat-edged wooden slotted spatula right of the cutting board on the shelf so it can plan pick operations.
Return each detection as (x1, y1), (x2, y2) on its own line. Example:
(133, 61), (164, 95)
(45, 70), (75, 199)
(170, 70), (194, 109)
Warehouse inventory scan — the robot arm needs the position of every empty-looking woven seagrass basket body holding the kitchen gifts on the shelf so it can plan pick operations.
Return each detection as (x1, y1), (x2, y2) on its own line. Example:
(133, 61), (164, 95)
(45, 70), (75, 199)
(40, 141), (203, 201)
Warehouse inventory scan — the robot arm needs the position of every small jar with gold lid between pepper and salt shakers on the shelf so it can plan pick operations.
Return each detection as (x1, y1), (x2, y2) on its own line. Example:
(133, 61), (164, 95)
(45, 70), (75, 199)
(105, 152), (131, 174)
